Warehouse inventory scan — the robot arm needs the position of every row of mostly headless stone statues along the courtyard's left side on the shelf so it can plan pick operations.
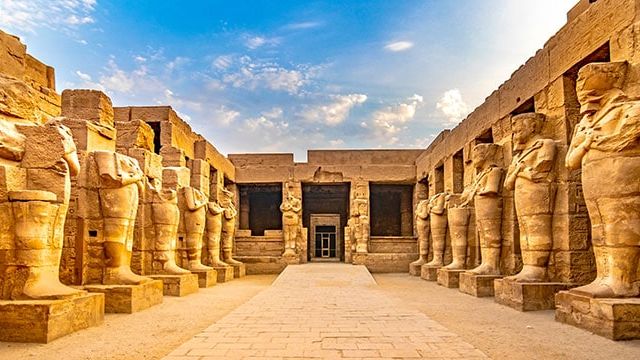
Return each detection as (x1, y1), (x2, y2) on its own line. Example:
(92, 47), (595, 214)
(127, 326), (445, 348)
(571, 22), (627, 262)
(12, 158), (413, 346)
(0, 119), (237, 300)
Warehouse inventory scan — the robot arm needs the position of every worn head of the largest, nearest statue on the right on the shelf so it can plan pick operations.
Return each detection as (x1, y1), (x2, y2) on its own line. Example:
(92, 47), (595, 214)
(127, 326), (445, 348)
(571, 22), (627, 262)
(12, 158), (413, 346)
(576, 61), (629, 113)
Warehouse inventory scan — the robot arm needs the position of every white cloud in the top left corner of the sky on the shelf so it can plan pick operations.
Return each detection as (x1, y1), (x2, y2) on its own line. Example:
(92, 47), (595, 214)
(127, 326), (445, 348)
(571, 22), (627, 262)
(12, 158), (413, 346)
(0, 0), (96, 34)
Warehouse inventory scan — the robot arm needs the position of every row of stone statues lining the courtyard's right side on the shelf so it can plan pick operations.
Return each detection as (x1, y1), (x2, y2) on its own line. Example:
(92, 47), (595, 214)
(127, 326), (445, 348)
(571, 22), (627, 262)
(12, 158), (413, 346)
(413, 62), (640, 298)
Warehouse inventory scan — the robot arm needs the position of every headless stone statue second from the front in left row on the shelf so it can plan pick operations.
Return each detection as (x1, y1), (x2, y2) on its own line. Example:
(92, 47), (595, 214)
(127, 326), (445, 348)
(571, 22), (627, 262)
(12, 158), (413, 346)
(93, 151), (150, 285)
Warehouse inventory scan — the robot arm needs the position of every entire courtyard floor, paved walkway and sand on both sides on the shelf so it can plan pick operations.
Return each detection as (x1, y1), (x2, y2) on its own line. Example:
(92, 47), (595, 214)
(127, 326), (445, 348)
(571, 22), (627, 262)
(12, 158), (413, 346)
(0, 264), (640, 360)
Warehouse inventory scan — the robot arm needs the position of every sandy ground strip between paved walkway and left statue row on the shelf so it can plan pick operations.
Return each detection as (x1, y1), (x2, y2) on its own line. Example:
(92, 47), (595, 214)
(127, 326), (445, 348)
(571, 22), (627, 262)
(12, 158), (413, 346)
(0, 275), (276, 360)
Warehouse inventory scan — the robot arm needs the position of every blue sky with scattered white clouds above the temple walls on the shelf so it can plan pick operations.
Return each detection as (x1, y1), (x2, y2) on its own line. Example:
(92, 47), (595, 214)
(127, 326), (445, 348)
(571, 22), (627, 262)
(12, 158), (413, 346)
(0, 0), (576, 161)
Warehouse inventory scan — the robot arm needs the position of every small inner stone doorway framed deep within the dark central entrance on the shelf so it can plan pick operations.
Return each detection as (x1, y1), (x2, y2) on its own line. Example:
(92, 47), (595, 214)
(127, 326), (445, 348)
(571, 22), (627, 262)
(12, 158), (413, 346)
(309, 214), (342, 261)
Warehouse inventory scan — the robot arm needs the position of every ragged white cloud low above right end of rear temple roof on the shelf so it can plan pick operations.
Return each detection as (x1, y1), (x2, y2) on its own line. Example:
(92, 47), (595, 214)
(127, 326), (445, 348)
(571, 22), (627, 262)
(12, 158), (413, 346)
(368, 95), (424, 144)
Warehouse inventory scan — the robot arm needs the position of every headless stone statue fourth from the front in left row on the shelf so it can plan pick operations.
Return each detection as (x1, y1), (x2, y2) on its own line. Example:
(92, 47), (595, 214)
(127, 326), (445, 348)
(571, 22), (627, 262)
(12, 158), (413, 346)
(178, 186), (212, 271)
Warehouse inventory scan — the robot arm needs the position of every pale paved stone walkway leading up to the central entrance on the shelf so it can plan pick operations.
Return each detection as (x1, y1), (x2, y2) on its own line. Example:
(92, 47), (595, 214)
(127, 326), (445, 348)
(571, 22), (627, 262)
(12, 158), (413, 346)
(165, 264), (486, 360)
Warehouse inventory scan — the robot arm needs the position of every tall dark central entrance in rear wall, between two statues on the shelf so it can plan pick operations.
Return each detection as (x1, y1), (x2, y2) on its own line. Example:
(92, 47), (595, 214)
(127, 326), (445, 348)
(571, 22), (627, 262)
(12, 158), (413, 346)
(302, 184), (349, 261)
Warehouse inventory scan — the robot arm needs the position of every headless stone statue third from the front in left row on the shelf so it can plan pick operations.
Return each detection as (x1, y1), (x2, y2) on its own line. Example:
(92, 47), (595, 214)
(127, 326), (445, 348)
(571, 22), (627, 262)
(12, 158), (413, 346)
(147, 181), (191, 275)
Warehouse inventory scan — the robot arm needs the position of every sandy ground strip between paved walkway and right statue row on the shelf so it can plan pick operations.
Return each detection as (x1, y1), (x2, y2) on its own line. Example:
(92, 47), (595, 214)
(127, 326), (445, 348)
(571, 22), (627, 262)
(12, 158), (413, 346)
(374, 274), (640, 360)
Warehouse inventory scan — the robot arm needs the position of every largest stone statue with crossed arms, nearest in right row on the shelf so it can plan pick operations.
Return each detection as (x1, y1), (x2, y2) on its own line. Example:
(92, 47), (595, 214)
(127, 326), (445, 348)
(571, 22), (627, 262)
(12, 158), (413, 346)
(566, 62), (640, 298)
